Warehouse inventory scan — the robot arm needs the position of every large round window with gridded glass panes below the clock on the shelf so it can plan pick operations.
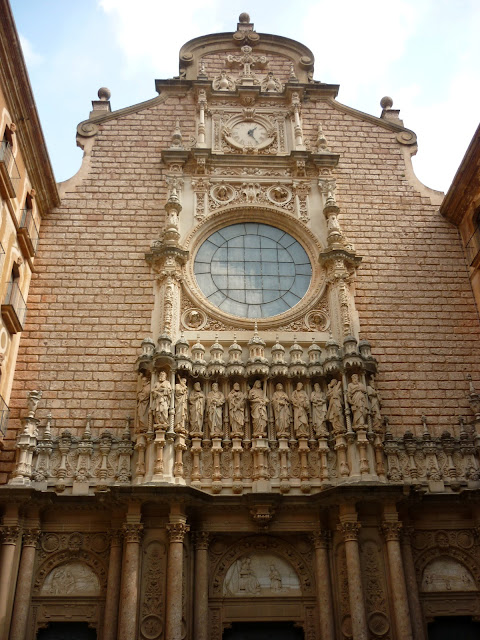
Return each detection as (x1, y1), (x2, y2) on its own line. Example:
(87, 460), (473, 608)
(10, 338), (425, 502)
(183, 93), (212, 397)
(194, 222), (312, 318)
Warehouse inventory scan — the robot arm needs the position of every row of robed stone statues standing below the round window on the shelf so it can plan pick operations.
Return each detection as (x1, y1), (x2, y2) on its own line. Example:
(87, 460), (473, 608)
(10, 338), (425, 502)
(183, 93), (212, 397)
(137, 371), (382, 438)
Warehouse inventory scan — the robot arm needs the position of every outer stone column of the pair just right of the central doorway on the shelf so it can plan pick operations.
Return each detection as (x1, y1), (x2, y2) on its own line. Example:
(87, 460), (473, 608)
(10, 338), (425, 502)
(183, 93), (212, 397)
(340, 504), (368, 640)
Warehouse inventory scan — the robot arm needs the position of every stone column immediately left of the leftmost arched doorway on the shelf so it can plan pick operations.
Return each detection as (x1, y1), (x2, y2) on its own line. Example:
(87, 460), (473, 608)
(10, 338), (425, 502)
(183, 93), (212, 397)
(10, 528), (40, 640)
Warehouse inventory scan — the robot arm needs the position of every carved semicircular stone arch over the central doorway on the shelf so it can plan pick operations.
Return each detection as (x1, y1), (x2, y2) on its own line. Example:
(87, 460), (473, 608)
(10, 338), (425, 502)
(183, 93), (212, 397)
(210, 536), (315, 597)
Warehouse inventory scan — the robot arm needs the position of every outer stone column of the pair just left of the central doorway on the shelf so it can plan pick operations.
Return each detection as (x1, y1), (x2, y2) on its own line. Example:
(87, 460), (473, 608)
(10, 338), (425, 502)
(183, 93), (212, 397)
(165, 515), (190, 640)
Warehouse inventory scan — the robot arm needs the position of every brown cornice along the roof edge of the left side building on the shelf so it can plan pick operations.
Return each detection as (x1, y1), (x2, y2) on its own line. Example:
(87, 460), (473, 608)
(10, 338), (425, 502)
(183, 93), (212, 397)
(0, 0), (60, 214)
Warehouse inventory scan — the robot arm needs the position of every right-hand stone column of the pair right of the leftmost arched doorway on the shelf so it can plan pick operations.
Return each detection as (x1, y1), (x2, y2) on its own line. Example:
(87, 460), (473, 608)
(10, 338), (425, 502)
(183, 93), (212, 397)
(117, 523), (143, 640)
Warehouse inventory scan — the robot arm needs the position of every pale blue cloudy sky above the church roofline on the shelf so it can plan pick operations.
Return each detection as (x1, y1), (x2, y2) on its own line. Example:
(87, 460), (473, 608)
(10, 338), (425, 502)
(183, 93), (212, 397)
(10, 0), (480, 191)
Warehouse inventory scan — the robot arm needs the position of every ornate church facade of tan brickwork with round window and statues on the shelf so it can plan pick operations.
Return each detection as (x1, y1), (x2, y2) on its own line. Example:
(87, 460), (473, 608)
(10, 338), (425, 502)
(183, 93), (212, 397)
(0, 14), (480, 640)
